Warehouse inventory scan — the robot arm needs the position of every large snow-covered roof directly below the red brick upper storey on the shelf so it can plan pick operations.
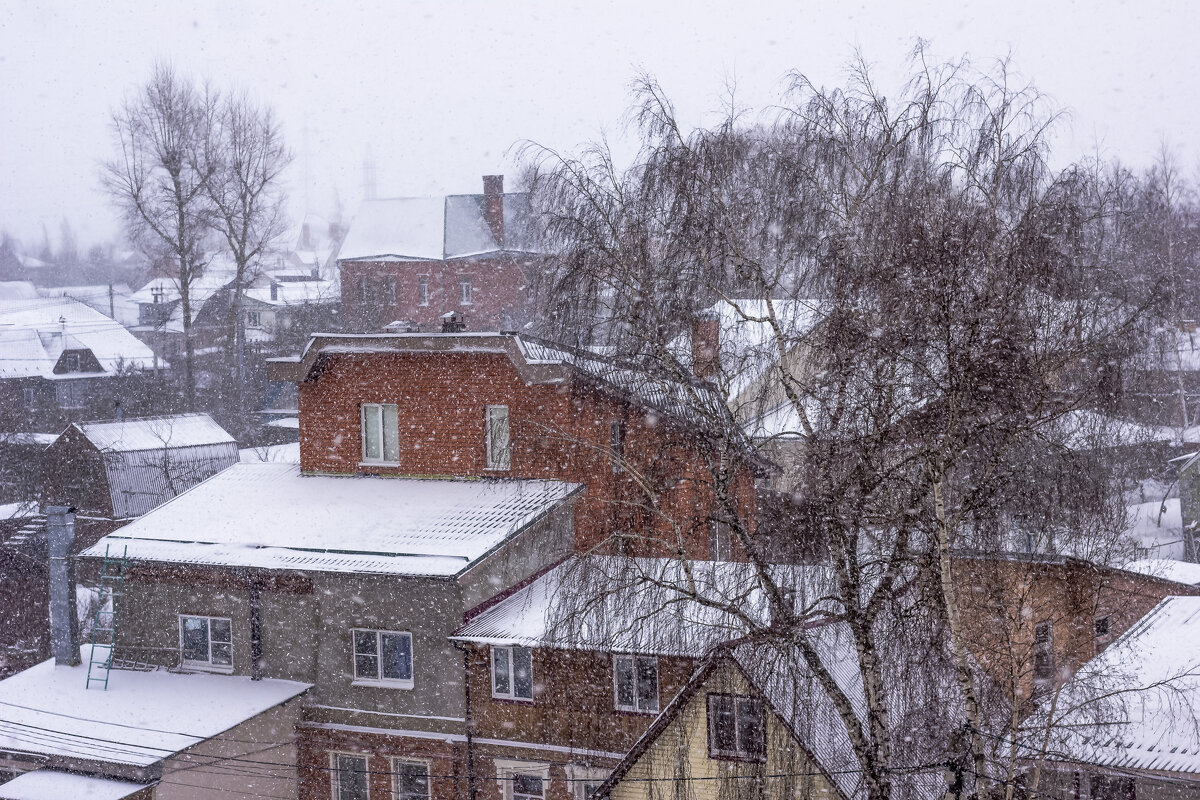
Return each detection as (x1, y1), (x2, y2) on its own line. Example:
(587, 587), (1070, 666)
(83, 463), (582, 577)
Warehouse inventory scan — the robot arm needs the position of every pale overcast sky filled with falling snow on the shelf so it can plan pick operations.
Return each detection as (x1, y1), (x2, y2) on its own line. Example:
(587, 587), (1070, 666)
(0, 0), (1200, 249)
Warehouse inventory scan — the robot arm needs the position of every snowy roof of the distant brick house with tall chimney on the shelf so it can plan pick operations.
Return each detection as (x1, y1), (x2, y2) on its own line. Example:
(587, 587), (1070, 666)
(337, 193), (542, 261)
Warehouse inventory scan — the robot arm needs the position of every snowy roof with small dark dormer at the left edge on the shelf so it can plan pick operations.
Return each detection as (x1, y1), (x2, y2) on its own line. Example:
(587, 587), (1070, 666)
(0, 297), (154, 380)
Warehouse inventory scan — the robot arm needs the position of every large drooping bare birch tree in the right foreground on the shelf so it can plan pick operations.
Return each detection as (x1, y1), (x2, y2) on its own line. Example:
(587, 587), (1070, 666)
(527, 48), (1154, 800)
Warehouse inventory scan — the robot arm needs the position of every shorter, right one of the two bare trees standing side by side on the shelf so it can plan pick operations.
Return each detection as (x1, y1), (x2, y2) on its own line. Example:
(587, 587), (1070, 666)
(204, 95), (292, 411)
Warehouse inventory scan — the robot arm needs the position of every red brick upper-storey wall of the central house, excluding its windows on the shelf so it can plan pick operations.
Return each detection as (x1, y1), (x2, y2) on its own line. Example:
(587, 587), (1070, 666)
(299, 353), (755, 558)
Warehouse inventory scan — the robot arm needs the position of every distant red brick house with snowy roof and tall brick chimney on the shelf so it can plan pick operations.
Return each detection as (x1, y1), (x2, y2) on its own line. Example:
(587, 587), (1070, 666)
(337, 175), (544, 331)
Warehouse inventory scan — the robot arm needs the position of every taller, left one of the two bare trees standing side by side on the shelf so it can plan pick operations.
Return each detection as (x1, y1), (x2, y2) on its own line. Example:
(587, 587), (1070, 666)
(102, 64), (217, 409)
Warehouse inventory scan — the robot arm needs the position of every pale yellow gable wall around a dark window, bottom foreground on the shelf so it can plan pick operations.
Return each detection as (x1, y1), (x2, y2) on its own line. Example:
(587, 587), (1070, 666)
(610, 666), (840, 800)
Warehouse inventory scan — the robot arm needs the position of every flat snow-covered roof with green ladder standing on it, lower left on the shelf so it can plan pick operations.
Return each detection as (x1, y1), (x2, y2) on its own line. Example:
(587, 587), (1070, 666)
(0, 645), (310, 767)
